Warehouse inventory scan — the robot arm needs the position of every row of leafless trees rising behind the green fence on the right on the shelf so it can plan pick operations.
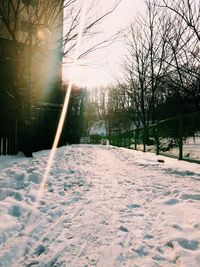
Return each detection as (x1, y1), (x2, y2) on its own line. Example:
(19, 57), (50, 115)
(107, 0), (200, 135)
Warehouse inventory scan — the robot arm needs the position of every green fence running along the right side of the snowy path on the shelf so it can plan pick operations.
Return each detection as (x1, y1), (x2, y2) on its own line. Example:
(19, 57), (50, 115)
(109, 112), (200, 163)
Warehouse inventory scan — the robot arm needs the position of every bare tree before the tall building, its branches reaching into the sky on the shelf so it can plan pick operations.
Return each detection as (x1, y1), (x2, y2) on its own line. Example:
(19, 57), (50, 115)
(0, 0), (121, 114)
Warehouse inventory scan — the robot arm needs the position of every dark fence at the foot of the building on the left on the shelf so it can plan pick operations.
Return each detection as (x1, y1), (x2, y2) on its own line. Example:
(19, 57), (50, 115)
(0, 103), (66, 155)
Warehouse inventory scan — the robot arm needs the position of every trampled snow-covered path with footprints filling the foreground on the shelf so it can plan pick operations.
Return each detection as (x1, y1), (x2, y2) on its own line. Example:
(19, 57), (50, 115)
(0, 145), (200, 267)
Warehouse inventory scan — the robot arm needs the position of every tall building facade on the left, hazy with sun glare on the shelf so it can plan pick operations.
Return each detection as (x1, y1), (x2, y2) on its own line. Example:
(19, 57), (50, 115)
(0, 0), (63, 154)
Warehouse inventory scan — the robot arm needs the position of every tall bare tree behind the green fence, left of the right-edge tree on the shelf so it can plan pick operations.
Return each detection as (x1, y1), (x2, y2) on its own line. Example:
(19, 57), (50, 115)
(124, 1), (169, 127)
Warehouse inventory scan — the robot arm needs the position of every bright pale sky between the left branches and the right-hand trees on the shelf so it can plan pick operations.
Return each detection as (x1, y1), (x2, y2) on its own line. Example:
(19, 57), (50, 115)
(63, 0), (144, 88)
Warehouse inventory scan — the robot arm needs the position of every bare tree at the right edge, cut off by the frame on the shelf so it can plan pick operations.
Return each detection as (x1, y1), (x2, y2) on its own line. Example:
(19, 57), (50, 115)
(157, 0), (200, 112)
